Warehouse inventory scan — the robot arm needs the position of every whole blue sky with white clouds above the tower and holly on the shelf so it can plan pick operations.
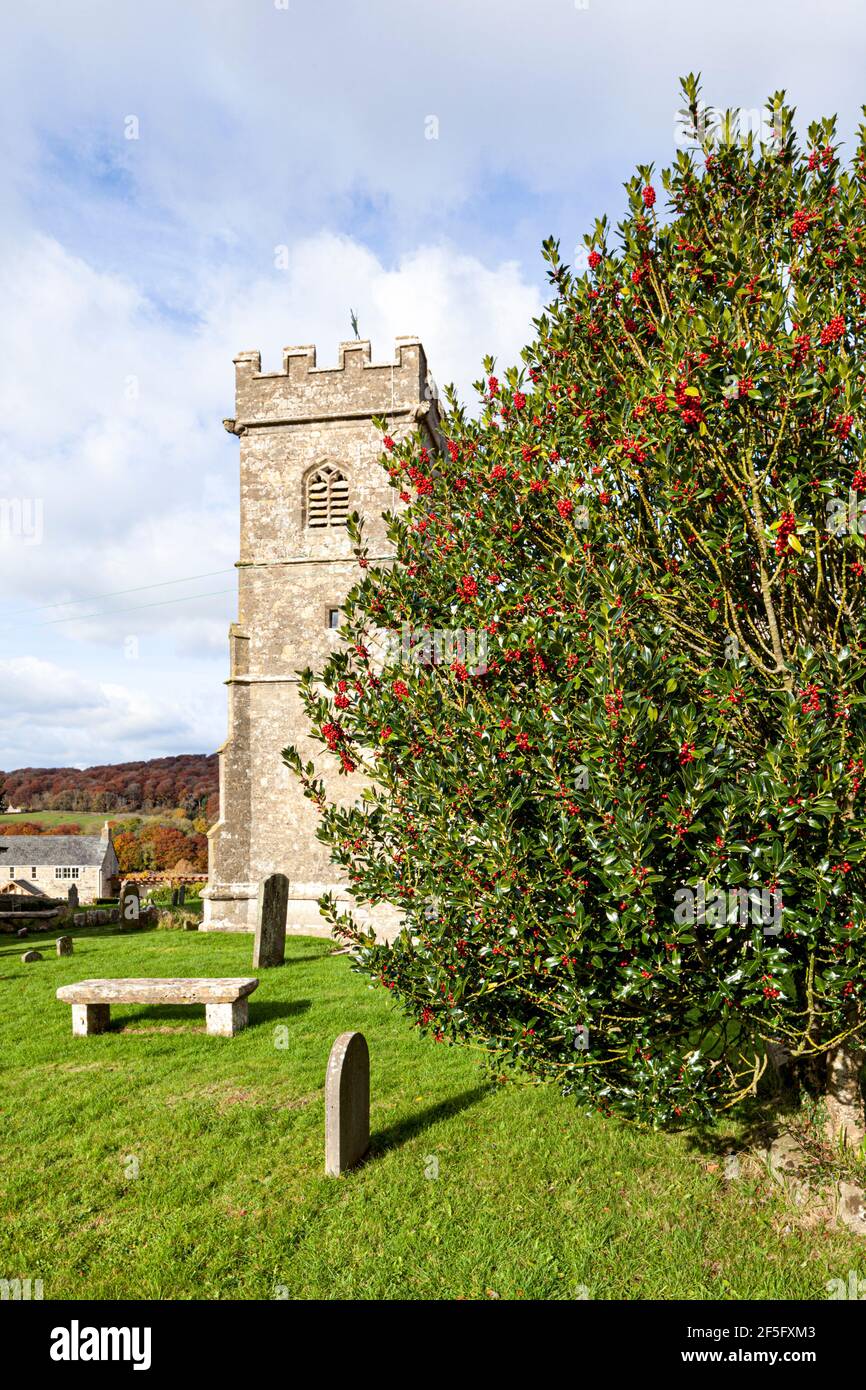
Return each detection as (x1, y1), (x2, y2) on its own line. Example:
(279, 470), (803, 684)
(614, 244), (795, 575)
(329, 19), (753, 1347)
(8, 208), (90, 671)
(0, 0), (866, 770)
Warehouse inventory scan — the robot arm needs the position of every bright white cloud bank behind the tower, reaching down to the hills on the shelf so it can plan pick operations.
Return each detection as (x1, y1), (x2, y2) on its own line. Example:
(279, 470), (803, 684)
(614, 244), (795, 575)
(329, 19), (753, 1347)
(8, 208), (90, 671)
(0, 232), (539, 766)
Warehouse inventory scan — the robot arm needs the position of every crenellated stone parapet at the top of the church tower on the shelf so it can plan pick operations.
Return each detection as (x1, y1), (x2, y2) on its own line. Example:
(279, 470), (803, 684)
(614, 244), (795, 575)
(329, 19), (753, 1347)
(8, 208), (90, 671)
(235, 336), (430, 431)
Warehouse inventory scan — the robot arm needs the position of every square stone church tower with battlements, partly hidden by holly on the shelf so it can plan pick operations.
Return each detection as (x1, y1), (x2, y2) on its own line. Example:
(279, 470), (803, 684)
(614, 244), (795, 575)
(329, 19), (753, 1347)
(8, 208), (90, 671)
(203, 338), (439, 934)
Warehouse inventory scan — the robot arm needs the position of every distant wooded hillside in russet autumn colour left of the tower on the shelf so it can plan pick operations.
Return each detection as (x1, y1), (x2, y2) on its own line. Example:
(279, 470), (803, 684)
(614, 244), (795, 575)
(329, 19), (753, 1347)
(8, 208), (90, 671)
(0, 753), (220, 820)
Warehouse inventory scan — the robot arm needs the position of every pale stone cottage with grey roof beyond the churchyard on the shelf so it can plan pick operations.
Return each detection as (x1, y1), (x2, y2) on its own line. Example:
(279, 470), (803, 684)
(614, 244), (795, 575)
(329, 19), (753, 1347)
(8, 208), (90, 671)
(0, 821), (120, 902)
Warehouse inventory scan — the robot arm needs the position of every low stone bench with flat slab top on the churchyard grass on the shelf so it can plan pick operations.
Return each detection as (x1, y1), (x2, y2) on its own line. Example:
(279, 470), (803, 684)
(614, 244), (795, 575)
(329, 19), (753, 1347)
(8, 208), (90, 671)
(57, 977), (259, 1038)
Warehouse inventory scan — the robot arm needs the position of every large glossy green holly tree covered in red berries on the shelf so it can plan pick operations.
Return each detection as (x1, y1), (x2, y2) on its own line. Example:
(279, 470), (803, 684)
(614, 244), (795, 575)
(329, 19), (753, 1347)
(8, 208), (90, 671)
(285, 78), (866, 1138)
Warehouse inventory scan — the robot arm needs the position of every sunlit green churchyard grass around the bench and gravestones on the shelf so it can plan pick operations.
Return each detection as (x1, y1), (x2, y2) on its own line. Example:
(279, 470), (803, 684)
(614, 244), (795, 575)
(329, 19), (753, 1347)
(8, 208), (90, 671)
(0, 927), (865, 1300)
